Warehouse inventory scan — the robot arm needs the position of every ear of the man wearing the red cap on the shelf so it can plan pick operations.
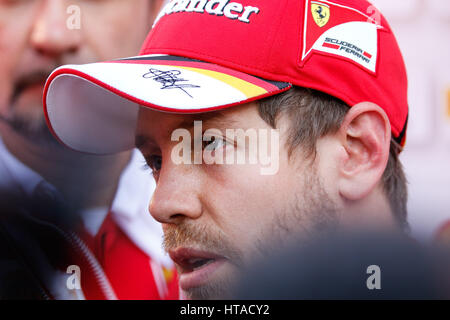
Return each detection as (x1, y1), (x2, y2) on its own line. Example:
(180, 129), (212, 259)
(338, 102), (391, 200)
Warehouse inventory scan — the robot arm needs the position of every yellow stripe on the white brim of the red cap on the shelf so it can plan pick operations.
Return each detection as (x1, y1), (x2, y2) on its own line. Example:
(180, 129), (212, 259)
(177, 66), (268, 98)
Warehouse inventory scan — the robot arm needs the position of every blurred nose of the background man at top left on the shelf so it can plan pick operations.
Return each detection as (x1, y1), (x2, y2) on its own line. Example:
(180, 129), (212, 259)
(30, 0), (82, 56)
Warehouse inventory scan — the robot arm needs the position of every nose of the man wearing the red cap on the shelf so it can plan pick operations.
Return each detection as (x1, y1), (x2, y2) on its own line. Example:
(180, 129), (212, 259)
(149, 160), (203, 224)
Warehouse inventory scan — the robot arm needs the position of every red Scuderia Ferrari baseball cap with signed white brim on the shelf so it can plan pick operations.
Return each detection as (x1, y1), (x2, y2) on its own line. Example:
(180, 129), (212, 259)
(44, 0), (408, 154)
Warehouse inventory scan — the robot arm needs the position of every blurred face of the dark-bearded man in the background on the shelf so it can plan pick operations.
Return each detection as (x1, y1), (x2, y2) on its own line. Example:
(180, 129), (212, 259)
(0, 0), (161, 141)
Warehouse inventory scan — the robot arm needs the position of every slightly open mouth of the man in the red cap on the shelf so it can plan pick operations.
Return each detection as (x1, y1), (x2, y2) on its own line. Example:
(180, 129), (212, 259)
(169, 248), (227, 290)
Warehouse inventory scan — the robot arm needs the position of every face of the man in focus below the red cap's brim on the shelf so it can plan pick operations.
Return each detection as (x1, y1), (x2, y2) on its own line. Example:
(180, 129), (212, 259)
(136, 103), (335, 299)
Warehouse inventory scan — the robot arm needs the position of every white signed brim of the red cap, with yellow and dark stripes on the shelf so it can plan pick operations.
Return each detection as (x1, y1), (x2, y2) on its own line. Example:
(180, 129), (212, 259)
(44, 55), (291, 154)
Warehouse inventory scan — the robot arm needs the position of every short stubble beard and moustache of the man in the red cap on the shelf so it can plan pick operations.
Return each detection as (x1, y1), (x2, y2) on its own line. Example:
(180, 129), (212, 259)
(163, 165), (338, 300)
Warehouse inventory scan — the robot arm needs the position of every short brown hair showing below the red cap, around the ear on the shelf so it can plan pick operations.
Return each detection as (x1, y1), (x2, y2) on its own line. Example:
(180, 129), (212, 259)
(259, 87), (408, 227)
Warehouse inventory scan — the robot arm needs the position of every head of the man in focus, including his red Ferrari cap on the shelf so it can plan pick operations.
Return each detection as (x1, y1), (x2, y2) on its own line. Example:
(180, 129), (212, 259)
(45, 0), (408, 298)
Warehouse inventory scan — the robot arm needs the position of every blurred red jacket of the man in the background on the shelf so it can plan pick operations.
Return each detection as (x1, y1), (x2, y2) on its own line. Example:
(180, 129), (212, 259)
(78, 213), (179, 300)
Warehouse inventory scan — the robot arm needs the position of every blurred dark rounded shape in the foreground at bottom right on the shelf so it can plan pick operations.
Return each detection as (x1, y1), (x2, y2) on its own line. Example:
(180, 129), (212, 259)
(233, 230), (450, 300)
